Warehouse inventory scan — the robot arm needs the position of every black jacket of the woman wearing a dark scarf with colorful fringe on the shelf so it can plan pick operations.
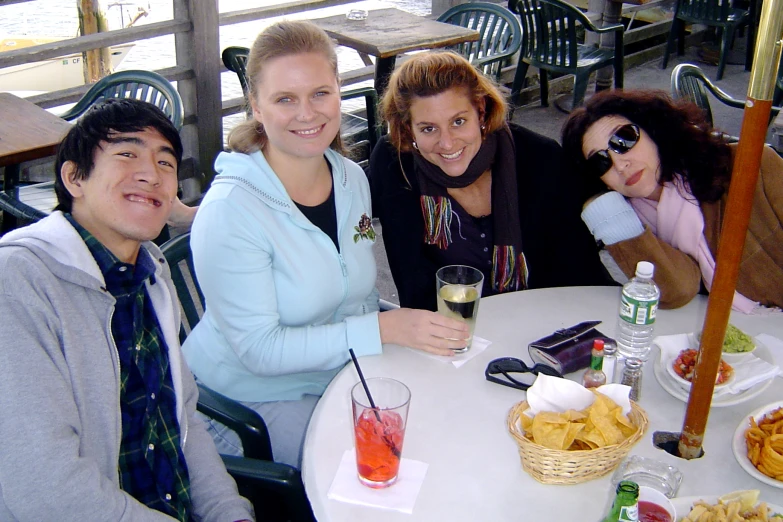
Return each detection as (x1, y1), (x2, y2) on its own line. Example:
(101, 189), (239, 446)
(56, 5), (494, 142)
(370, 124), (616, 310)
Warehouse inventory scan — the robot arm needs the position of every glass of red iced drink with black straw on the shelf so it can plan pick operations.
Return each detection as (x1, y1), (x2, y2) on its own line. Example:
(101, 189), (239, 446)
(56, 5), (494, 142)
(351, 377), (411, 489)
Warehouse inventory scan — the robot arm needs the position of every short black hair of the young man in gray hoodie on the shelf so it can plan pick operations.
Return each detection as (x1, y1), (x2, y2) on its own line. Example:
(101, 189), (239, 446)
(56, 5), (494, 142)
(54, 98), (183, 212)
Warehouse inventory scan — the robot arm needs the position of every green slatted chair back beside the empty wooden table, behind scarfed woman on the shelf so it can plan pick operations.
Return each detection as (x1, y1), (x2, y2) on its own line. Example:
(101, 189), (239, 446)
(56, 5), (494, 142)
(438, 2), (522, 80)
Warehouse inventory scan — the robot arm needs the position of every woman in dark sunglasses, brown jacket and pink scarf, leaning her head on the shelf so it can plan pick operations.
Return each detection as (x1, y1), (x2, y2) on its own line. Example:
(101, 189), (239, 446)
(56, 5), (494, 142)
(563, 91), (783, 313)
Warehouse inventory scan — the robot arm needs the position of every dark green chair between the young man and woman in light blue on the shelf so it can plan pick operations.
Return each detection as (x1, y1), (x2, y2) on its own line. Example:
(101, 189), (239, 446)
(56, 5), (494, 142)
(161, 233), (315, 522)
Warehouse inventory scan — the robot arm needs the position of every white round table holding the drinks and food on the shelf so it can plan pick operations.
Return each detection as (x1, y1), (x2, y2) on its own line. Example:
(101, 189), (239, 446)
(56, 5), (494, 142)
(302, 287), (783, 522)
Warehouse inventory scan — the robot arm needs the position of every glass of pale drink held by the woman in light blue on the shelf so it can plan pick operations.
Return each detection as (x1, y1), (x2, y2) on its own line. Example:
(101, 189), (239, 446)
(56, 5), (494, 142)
(435, 265), (484, 353)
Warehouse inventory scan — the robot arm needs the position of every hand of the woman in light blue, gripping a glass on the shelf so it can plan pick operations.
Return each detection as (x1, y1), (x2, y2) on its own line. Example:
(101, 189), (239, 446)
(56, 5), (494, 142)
(378, 308), (470, 356)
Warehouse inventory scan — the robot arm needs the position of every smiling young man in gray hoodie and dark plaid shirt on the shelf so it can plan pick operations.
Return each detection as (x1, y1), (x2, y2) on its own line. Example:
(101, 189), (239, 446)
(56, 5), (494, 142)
(0, 100), (252, 522)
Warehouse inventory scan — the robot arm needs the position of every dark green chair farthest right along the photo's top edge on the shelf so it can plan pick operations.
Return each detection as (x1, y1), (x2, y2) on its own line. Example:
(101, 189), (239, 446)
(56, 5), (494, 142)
(661, 0), (750, 80)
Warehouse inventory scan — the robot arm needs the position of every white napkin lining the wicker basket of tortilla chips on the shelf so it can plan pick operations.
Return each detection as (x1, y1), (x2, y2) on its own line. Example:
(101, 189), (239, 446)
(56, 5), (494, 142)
(525, 373), (631, 418)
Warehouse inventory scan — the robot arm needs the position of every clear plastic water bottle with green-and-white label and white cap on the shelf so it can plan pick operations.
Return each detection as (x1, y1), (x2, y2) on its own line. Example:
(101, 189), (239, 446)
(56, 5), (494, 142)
(615, 261), (661, 361)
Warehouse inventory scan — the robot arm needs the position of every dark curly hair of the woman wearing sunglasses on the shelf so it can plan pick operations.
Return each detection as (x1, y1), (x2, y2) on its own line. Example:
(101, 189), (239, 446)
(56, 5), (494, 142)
(562, 90), (732, 203)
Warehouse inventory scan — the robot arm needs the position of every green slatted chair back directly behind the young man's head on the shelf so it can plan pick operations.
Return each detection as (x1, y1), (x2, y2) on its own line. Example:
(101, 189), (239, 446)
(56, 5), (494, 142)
(60, 70), (185, 130)
